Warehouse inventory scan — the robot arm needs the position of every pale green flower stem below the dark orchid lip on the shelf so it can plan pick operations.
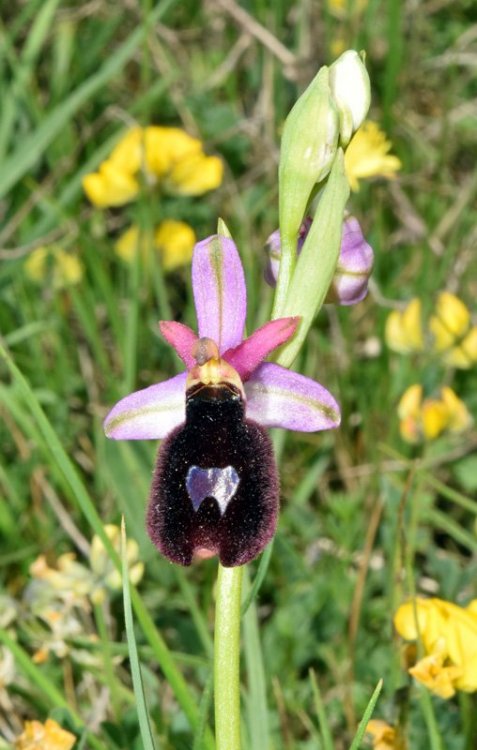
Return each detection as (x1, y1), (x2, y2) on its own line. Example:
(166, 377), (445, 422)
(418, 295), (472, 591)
(214, 563), (243, 750)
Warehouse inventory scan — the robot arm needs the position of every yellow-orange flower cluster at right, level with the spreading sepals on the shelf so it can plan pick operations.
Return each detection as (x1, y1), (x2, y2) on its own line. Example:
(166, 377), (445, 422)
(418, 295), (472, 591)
(398, 384), (472, 443)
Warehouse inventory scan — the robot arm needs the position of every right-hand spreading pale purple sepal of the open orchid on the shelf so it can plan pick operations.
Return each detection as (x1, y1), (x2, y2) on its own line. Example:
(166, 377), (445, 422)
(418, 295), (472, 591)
(245, 362), (341, 432)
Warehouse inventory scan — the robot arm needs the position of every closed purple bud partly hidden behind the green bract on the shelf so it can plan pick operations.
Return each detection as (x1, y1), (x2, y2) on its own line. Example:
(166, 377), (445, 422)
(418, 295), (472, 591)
(265, 216), (374, 305)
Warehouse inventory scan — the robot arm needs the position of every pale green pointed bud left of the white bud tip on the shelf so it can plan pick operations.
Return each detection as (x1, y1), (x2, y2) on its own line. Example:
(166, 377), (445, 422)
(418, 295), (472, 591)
(279, 67), (339, 244)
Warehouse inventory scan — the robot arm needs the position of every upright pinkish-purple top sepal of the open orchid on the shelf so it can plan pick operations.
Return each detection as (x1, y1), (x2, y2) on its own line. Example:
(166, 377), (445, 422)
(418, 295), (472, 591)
(192, 234), (247, 354)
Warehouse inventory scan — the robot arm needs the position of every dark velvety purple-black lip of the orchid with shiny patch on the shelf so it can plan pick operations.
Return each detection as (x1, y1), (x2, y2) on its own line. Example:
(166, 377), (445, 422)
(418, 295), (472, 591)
(147, 383), (279, 567)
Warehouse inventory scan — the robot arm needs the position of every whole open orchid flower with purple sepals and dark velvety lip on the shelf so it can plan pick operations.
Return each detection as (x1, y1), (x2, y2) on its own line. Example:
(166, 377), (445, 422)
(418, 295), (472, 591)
(104, 235), (340, 567)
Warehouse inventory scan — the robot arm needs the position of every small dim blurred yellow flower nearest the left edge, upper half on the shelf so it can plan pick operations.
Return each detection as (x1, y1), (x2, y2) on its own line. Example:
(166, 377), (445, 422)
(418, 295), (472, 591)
(25, 250), (83, 290)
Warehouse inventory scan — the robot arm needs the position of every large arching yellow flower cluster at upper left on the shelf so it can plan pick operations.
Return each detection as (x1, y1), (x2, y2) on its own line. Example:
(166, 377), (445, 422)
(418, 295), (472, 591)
(83, 125), (223, 208)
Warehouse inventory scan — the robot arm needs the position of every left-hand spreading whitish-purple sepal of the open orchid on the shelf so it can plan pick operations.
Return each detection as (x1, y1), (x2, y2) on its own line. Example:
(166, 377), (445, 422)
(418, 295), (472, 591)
(104, 372), (187, 440)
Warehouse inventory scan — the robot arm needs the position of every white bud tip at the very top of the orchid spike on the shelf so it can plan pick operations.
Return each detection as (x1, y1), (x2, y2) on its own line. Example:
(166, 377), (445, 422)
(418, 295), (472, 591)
(330, 50), (371, 146)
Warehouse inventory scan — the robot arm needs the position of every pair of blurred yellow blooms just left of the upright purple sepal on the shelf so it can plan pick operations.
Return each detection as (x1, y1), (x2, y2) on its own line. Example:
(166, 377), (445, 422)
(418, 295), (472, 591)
(114, 219), (196, 271)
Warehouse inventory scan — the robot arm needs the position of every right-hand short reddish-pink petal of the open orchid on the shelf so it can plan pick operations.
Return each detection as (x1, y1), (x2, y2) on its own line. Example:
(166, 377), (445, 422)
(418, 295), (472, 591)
(224, 317), (300, 380)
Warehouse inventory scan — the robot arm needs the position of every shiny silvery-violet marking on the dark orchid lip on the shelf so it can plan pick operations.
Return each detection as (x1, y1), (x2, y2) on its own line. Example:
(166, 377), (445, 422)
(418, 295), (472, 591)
(186, 466), (240, 516)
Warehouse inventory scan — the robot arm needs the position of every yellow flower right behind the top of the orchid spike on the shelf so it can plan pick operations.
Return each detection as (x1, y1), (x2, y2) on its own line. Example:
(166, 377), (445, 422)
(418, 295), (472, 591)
(345, 120), (401, 191)
